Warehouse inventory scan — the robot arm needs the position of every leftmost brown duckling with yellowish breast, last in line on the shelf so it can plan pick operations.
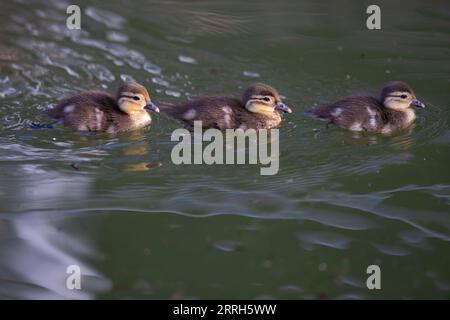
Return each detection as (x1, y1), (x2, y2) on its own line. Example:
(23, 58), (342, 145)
(47, 82), (159, 134)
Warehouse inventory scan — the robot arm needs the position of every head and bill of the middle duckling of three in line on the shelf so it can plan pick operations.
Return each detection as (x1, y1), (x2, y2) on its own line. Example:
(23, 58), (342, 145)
(242, 83), (292, 115)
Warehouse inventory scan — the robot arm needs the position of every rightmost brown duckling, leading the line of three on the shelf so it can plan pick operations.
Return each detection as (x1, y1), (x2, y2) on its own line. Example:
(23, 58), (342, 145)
(311, 81), (425, 134)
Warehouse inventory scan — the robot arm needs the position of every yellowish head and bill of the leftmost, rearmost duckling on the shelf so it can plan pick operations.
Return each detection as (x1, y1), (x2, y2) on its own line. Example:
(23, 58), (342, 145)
(116, 82), (159, 116)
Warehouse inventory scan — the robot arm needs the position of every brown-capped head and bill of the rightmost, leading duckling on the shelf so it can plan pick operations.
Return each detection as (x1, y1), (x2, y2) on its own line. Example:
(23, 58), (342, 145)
(381, 81), (425, 111)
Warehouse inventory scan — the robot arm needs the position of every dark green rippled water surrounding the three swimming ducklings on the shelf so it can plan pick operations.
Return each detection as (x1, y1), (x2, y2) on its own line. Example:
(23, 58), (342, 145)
(0, 0), (450, 299)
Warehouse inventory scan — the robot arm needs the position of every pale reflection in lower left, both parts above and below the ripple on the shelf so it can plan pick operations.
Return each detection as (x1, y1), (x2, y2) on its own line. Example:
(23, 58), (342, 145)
(0, 164), (111, 299)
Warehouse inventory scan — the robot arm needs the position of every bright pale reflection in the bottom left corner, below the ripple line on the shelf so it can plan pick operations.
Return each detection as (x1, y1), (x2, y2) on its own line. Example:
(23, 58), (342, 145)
(0, 215), (111, 299)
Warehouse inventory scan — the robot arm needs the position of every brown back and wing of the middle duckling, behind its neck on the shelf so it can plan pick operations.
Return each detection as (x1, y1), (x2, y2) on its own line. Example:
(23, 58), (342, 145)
(158, 96), (243, 129)
